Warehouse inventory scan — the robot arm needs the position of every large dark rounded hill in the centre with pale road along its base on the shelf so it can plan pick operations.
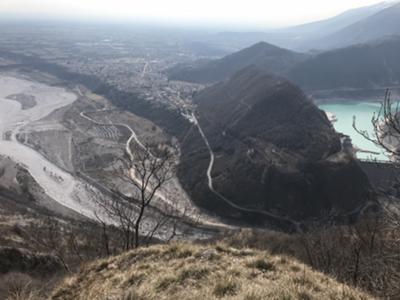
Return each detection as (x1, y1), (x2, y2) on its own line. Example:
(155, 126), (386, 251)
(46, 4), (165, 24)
(179, 68), (371, 225)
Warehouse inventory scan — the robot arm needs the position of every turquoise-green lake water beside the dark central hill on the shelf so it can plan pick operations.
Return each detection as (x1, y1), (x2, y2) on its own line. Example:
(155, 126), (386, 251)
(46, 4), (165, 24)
(319, 102), (387, 160)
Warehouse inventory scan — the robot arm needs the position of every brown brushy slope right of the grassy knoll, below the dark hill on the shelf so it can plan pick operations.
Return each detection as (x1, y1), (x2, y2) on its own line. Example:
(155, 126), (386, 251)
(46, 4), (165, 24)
(222, 221), (400, 299)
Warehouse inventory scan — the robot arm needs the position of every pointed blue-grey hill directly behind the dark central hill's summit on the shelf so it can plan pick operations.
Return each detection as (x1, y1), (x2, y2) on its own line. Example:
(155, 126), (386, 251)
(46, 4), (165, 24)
(168, 42), (307, 83)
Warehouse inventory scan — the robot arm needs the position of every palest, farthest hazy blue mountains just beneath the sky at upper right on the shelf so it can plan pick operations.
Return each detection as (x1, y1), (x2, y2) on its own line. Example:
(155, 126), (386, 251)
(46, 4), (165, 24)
(206, 1), (400, 52)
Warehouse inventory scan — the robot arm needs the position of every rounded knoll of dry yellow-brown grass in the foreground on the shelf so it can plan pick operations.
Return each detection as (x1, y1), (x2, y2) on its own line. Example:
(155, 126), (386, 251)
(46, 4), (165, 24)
(52, 243), (372, 300)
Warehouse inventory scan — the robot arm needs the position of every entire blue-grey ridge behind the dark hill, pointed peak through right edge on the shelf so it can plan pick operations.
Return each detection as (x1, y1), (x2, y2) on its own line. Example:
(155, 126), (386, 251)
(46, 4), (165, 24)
(169, 36), (400, 91)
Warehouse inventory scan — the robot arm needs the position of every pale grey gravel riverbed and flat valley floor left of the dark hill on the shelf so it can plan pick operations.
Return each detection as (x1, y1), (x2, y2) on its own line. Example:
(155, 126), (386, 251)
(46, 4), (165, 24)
(0, 72), (226, 238)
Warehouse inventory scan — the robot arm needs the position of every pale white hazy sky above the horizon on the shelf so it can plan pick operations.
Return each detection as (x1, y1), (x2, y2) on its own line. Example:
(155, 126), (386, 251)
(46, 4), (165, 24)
(0, 0), (392, 26)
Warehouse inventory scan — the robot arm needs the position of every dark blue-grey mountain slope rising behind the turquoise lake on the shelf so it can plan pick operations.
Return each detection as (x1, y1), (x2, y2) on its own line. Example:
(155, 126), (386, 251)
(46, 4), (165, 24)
(289, 36), (400, 90)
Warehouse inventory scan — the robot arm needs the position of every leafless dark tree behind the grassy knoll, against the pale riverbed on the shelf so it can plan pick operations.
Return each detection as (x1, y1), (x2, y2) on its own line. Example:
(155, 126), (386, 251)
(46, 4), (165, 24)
(96, 145), (192, 250)
